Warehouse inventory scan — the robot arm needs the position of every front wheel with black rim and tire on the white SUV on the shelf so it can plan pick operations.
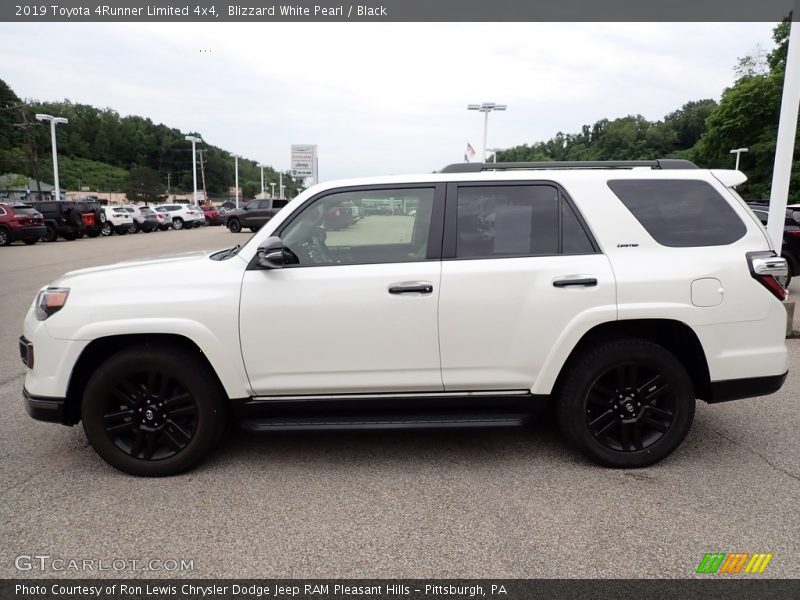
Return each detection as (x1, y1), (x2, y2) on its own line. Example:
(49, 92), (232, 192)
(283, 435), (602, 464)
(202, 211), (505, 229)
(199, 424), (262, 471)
(81, 344), (225, 477)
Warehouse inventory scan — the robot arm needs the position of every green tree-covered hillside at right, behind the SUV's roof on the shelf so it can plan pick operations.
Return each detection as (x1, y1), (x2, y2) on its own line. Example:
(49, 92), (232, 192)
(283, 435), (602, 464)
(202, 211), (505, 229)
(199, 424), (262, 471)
(497, 21), (800, 202)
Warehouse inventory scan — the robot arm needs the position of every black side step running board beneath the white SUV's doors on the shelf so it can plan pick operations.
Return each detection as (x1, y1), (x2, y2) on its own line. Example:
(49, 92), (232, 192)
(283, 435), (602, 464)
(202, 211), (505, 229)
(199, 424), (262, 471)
(241, 412), (531, 433)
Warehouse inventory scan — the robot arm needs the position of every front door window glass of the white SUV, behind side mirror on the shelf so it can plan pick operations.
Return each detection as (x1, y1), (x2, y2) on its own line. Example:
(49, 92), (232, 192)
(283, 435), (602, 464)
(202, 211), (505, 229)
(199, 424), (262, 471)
(281, 188), (434, 266)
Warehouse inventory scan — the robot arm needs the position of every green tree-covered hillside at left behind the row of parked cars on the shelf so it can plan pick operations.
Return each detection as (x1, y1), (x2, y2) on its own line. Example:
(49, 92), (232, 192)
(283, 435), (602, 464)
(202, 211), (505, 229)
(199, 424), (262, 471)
(0, 80), (302, 197)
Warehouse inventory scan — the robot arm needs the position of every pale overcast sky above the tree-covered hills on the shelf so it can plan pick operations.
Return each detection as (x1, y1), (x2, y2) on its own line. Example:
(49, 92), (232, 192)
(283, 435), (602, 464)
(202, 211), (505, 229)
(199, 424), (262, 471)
(0, 23), (775, 181)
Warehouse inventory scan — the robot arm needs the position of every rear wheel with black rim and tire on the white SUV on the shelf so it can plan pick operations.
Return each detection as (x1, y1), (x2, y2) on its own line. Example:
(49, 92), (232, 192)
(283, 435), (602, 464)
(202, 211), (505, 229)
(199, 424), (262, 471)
(556, 339), (695, 468)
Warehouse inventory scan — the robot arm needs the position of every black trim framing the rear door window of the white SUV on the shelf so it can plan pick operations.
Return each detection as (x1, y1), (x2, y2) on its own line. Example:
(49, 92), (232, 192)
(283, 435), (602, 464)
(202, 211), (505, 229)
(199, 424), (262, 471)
(442, 179), (602, 261)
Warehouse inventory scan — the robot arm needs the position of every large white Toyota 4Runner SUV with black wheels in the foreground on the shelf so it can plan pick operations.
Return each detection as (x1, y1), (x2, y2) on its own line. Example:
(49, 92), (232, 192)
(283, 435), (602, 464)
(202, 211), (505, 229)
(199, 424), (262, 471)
(20, 160), (788, 475)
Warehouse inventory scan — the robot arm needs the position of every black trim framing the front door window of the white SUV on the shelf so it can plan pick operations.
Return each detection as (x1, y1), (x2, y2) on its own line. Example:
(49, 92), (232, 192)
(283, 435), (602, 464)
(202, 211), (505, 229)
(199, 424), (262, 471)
(247, 181), (445, 270)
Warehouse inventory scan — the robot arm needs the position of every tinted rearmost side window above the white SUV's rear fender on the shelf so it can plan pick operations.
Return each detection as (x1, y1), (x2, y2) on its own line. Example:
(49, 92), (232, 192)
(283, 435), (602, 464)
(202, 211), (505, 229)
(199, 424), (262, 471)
(608, 179), (747, 248)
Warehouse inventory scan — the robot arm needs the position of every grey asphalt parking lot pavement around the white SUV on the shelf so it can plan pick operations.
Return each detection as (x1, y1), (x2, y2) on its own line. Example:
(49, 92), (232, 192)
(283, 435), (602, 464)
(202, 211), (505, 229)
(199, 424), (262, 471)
(0, 228), (800, 578)
